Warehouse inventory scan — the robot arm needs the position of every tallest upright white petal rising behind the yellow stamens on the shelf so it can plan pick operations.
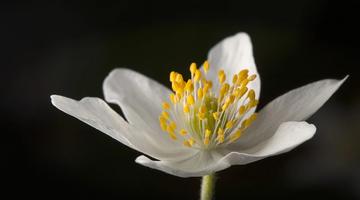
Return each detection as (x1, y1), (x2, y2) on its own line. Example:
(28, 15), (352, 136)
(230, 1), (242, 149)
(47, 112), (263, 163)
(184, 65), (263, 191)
(207, 33), (260, 98)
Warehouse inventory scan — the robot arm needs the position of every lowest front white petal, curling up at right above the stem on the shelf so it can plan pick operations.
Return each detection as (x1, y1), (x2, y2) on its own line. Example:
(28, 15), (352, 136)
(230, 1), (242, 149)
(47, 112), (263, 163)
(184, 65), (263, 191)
(136, 122), (316, 177)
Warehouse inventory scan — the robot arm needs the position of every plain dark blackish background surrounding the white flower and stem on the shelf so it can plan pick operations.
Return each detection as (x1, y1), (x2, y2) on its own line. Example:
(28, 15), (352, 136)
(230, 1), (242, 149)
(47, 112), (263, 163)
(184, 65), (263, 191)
(0, 0), (360, 199)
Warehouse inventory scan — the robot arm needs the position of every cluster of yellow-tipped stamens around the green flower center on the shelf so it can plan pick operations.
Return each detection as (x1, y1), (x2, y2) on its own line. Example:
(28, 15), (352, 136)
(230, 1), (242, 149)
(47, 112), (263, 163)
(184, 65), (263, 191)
(159, 61), (258, 149)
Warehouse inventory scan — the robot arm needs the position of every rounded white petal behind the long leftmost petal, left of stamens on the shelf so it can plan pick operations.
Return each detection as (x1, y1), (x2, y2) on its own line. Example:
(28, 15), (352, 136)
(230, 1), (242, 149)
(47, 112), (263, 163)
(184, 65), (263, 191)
(103, 68), (171, 133)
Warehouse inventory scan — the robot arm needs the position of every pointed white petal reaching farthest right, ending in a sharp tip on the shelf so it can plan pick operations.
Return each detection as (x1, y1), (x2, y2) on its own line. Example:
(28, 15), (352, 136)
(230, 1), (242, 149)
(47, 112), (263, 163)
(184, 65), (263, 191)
(233, 77), (347, 149)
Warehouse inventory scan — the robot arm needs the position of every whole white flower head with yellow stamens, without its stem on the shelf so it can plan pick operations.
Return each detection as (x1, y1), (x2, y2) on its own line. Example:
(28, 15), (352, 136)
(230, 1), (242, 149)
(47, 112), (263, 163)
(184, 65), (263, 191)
(51, 33), (347, 177)
